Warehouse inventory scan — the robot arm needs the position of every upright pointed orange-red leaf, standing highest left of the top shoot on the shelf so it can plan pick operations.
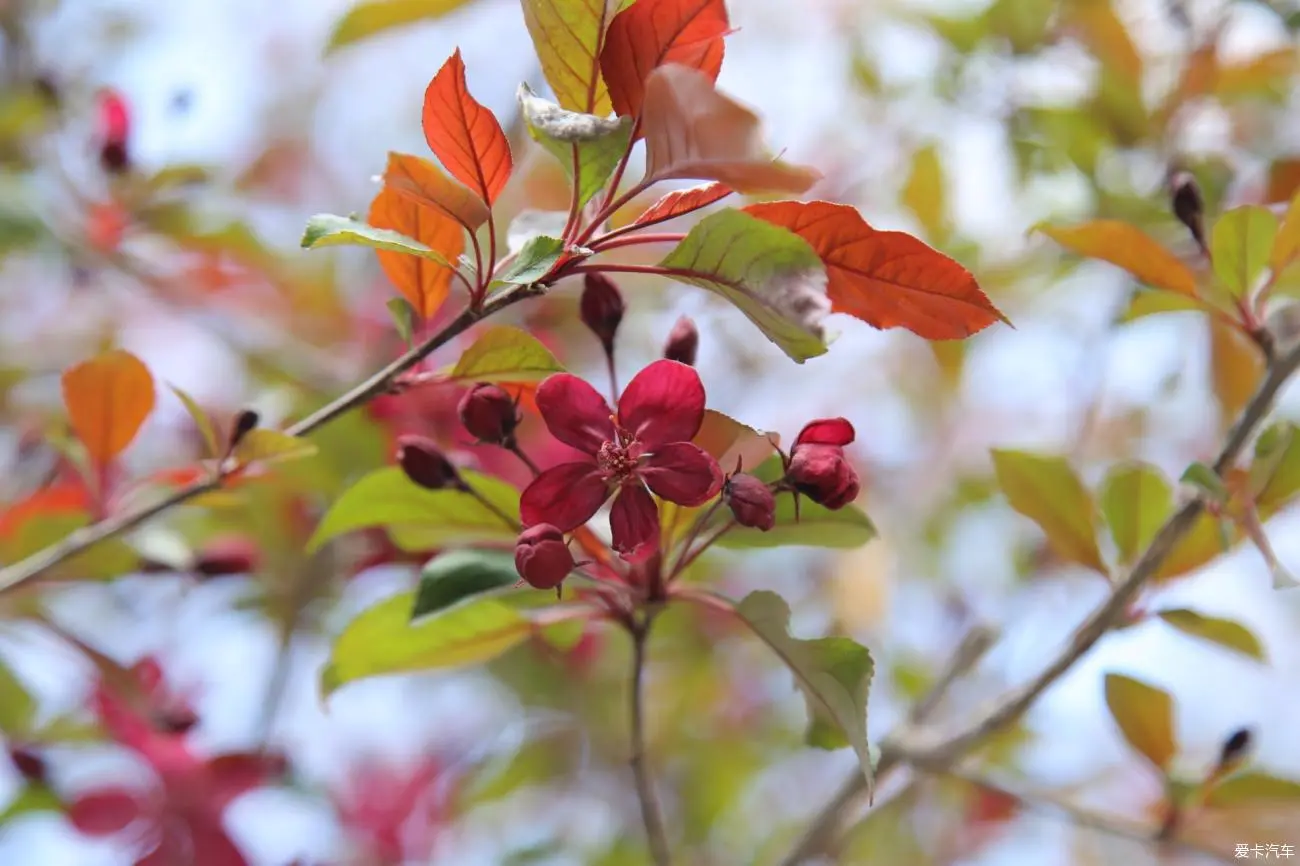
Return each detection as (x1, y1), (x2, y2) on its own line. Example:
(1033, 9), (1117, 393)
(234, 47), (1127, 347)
(423, 48), (514, 205)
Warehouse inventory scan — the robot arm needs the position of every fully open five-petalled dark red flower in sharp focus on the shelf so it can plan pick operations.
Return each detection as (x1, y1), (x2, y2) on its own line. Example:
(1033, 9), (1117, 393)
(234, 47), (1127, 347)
(520, 360), (723, 562)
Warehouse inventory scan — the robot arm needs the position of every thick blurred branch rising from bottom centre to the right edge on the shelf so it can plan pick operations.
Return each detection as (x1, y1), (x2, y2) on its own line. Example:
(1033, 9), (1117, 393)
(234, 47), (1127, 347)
(781, 345), (1300, 866)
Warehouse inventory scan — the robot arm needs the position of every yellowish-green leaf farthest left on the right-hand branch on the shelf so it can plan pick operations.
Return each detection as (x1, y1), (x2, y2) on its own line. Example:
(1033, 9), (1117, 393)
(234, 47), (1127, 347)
(992, 449), (1108, 575)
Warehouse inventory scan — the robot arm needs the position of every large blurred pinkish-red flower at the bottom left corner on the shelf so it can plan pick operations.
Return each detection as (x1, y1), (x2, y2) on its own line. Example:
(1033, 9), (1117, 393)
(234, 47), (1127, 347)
(68, 659), (282, 866)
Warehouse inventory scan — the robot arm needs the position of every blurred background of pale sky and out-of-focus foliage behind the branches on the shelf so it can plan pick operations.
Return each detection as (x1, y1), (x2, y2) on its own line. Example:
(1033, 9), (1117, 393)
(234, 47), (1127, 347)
(0, 0), (1300, 866)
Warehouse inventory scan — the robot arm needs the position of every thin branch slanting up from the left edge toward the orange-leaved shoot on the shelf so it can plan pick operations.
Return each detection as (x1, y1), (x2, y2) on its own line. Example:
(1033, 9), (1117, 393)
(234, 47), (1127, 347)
(0, 283), (545, 593)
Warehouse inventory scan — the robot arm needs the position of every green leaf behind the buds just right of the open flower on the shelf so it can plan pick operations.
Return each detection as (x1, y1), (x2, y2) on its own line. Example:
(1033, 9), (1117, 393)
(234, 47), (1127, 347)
(710, 456), (876, 550)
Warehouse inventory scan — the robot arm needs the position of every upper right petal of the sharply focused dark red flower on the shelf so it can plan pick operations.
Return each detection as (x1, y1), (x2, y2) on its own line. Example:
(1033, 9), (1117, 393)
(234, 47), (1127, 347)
(619, 360), (705, 449)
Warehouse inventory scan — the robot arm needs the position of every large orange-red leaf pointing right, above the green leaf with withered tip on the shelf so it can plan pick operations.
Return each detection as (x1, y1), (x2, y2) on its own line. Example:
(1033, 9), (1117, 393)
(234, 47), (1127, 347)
(744, 202), (1006, 339)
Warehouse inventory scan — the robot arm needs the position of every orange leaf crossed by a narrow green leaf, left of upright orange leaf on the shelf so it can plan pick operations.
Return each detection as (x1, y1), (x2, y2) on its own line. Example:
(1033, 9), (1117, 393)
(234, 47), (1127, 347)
(367, 186), (465, 319)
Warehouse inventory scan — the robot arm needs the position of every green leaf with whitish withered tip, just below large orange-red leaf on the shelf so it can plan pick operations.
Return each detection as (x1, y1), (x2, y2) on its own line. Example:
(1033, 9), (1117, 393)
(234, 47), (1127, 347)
(659, 208), (828, 364)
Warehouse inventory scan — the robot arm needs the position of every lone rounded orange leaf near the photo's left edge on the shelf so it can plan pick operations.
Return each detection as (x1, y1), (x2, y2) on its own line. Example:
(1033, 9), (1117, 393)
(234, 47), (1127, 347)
(62, 348), (155, 466)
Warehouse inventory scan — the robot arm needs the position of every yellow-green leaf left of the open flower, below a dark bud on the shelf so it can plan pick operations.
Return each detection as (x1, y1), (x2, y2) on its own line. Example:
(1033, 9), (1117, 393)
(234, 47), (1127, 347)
(307, 467), (519, 553)
